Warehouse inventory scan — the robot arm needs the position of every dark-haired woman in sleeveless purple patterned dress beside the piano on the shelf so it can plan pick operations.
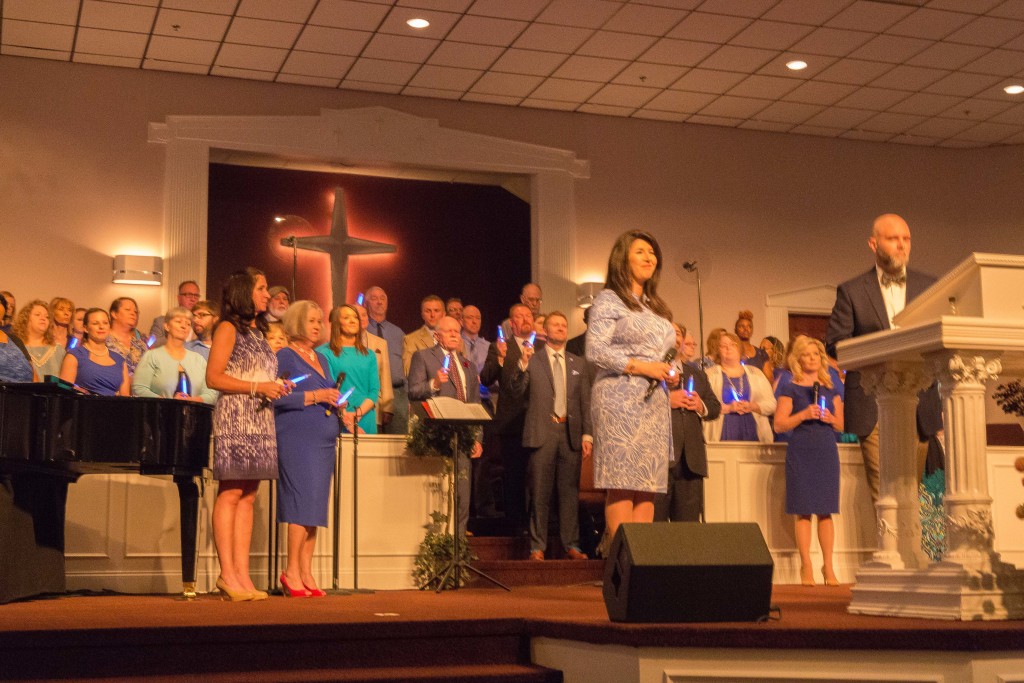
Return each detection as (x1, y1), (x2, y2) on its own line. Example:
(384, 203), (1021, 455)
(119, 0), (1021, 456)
(206, 268), (290, 602)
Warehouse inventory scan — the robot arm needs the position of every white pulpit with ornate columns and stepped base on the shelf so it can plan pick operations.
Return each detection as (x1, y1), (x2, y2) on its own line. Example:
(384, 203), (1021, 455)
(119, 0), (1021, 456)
(838, 254), (1024, 620)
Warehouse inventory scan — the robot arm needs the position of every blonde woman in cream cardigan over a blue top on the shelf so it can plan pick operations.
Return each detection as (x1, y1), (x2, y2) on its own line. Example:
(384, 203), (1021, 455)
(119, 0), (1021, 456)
(705, 332), (775, 443)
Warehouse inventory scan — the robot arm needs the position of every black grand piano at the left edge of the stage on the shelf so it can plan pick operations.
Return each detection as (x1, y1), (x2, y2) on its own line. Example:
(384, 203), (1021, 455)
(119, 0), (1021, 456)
(0, 381), (213, 603)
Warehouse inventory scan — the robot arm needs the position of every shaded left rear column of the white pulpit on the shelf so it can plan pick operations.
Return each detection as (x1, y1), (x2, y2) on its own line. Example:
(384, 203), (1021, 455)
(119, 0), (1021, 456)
(861, 360), (932, 569)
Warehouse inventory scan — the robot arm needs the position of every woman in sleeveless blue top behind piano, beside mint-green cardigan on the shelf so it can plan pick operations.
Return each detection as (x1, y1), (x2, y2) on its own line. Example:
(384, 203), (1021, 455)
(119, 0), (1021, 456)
(60, 308), (131, 396)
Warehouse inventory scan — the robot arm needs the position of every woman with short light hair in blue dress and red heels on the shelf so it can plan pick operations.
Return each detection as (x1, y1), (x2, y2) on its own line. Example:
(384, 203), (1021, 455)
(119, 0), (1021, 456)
(273, 300), (341, 598)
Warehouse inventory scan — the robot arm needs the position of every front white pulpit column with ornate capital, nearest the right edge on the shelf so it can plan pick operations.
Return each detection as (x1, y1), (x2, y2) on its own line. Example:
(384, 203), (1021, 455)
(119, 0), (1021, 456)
(929, 350), (1002, 573)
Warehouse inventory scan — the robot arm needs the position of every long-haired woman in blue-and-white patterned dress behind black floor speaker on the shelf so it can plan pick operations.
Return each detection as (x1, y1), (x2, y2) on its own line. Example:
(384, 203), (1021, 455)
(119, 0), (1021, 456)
(587, 230), (676, 539)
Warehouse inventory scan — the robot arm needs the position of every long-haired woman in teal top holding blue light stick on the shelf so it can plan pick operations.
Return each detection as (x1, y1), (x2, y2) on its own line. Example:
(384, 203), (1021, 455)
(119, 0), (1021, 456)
(316, 304), (381, 434)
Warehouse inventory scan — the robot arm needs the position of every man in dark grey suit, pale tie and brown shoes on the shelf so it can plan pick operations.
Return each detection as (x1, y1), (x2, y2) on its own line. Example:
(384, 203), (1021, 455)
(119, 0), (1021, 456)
(502, 311), (594, 560)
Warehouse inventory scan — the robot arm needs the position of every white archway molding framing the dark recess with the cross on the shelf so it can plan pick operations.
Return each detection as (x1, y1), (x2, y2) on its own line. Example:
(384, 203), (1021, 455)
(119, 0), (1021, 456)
(148, 106), (590, 311)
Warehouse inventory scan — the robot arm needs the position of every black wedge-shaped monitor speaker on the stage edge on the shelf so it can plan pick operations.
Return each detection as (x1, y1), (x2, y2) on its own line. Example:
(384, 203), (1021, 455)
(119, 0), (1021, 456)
(604, 522), (774, 623)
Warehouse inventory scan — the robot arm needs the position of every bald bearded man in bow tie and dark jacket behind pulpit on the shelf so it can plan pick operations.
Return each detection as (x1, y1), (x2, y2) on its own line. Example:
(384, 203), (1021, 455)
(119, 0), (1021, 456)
(825, 213), (942, 502)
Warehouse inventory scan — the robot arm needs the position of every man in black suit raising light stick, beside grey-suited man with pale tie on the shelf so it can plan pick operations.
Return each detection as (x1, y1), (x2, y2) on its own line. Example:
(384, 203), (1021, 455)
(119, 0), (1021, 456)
(480, 303), (544, 530)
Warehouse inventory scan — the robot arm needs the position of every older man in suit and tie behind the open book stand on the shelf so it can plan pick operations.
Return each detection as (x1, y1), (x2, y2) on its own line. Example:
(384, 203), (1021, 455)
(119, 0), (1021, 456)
(409, 316), (483, 533)
